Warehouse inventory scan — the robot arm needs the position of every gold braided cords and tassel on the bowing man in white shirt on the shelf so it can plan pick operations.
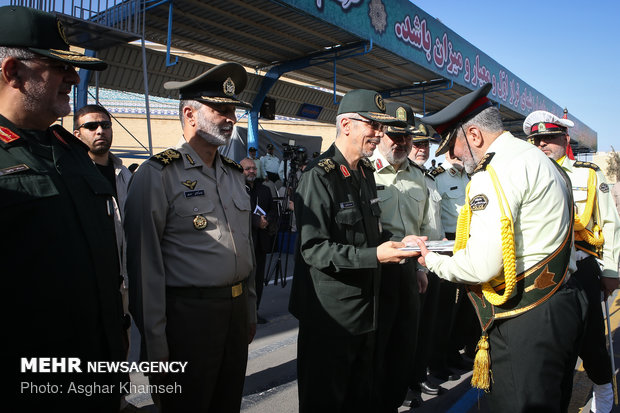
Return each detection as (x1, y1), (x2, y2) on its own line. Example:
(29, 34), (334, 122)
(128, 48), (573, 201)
(454, 165), (517, 391)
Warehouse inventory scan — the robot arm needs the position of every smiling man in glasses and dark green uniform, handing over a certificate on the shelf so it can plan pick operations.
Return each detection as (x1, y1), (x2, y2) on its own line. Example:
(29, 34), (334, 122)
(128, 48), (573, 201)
(289, 89), (417, 413)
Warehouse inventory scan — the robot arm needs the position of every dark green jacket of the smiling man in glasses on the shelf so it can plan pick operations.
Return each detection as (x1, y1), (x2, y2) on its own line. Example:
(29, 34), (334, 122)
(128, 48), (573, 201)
(289, 145), (389, 335)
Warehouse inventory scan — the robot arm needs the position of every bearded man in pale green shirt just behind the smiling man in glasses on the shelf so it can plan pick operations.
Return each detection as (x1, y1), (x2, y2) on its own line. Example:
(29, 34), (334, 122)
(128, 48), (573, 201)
(370, 102), (428, 412)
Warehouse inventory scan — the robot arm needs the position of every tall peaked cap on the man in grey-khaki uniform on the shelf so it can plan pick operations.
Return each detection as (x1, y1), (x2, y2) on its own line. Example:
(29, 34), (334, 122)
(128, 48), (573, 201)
(164, 62), (252, 109)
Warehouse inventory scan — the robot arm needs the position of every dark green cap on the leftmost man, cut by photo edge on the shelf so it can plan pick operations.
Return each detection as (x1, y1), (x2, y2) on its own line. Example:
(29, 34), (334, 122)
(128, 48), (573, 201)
(0, 6), (108, 70)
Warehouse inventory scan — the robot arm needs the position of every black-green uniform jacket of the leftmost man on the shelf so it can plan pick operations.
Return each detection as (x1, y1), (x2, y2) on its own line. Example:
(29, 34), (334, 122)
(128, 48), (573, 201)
(0, 116), (126, 411)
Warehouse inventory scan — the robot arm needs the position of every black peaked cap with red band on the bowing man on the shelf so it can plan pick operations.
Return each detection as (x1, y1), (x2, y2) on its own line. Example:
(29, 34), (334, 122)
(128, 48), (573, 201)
(422, 83), (493, 156)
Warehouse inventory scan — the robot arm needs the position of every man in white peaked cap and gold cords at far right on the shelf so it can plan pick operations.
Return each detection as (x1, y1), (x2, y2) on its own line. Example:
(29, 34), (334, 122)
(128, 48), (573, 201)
(523, 110), (620, 413)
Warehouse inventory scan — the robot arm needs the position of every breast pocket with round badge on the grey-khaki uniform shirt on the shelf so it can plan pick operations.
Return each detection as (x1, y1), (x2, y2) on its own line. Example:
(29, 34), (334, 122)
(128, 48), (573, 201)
(170, 198), (222, 240)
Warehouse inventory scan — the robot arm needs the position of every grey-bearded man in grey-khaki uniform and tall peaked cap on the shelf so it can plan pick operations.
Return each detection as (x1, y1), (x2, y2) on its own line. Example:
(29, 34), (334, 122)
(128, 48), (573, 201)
(125, 63), (256, 413)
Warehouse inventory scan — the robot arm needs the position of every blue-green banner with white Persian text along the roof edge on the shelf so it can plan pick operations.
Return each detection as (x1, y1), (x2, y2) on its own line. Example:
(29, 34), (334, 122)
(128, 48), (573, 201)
(279, 0), (597, 150)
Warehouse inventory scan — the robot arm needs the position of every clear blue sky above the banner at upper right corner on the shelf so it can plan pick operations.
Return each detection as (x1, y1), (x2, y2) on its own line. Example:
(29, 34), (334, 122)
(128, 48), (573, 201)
(410, 0), (620, 152)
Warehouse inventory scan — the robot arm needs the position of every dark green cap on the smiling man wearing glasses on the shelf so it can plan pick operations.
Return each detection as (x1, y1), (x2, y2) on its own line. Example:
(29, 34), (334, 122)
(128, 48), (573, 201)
(338, 89), (407, 124)
